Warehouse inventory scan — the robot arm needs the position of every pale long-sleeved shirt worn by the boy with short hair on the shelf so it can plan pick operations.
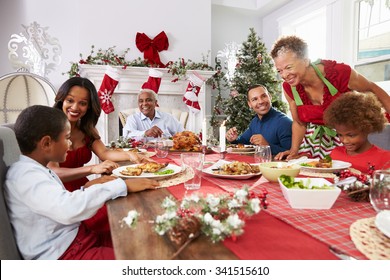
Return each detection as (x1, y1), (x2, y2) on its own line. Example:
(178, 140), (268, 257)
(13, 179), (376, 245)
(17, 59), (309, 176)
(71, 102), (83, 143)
(4, 155), (127, 260)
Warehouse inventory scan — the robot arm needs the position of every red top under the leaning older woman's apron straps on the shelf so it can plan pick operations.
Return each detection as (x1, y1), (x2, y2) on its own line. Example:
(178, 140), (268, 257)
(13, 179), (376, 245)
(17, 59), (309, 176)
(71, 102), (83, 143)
(283, 60), (351, 125)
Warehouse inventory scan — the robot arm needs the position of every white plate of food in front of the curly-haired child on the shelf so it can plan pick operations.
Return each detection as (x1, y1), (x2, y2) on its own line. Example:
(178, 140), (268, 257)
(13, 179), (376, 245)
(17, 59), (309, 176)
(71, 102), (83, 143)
(301, 157), (352, 173)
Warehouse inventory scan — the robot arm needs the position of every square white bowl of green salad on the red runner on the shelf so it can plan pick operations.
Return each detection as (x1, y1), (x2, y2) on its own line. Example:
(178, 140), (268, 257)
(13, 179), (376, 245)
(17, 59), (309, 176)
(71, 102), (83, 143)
(278, 175), (341, 209)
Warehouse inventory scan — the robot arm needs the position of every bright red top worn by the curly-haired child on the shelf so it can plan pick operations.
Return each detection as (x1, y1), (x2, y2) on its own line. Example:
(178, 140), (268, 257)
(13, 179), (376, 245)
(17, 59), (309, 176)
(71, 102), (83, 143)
(330, 145), (390, 174)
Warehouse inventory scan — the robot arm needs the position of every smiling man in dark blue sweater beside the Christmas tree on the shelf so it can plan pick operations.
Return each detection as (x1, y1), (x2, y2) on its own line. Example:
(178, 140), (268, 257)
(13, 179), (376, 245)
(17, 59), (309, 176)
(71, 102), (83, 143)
(226, 85), (292, 155)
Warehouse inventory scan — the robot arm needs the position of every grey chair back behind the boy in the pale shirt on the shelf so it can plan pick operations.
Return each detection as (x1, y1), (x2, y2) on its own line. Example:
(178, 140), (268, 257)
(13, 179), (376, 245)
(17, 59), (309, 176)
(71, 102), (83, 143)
(0, 125), (22, 260)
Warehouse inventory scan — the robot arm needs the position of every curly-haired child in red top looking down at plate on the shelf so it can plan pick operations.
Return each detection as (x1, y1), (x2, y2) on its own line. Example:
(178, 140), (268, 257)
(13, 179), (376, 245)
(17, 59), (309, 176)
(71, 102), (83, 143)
(324, 92), (390, 174)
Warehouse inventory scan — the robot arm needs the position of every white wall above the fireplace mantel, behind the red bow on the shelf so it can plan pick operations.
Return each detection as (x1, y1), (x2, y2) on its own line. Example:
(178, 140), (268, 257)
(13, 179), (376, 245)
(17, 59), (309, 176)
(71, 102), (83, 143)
(0, 0), (211, 88)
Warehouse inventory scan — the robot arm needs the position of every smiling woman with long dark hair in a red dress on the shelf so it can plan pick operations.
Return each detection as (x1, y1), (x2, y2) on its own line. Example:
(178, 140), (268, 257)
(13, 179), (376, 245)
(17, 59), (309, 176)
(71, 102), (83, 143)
(48, 77), (148, 231)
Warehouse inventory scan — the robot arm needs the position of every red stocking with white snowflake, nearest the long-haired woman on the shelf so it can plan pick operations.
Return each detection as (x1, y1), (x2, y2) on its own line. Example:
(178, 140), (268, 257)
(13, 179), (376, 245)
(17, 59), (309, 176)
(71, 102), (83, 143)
(98, 66), (119, 114)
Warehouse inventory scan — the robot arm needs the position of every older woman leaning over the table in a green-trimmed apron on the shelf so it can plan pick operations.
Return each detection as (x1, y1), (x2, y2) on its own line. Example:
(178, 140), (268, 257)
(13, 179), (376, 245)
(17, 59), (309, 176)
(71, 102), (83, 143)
(271, 36), (390, 160)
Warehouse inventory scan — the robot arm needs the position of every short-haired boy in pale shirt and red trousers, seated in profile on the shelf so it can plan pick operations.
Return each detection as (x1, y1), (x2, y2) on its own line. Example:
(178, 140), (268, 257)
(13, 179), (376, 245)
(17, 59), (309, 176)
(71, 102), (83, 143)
(5, 105), (158, 259)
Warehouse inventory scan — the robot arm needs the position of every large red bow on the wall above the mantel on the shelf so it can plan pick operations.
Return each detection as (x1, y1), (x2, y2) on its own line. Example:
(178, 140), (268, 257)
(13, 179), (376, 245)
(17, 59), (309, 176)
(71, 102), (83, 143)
(135, 31), (169, 68)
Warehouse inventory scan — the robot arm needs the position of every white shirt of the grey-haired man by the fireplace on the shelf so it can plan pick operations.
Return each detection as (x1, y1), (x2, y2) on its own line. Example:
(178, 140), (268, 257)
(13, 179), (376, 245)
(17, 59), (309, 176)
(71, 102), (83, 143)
(122, 110), (184, 140)
